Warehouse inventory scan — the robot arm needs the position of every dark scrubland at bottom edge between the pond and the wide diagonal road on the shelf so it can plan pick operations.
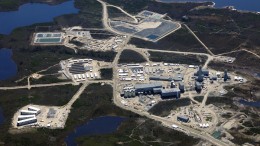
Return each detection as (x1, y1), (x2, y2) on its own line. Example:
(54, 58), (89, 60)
(77, 119), (199, 146)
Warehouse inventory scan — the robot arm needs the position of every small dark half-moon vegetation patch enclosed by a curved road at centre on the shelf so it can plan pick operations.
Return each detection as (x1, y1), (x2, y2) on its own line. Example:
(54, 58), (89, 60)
(118, 49), (147, 63)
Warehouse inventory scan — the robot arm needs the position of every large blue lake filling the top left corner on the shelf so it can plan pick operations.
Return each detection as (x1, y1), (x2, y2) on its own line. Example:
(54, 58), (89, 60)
(0, 1), (78, 34)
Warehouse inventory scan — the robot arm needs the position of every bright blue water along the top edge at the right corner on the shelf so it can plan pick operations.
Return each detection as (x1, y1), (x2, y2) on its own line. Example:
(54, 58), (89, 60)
(160, 0), (260, 12)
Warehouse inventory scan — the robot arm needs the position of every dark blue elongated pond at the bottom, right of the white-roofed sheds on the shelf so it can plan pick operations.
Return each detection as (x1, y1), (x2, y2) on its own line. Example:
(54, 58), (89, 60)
(65, 116), (125, 146)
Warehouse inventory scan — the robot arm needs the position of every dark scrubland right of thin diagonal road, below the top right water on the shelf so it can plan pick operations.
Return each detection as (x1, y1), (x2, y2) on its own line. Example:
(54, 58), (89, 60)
(187, 8), (260, 54)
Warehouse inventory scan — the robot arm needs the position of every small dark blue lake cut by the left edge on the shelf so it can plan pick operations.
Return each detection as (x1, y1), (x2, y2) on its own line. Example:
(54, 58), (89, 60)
(0, 48), (17, 81)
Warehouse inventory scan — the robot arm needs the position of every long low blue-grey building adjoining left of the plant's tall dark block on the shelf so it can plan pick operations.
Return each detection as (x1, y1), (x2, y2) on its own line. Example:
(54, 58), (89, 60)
(135, 83), (162, 94)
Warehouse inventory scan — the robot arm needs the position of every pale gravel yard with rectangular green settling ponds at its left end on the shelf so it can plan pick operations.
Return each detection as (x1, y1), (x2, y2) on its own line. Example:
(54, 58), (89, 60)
(31, 26), (127, 52)
